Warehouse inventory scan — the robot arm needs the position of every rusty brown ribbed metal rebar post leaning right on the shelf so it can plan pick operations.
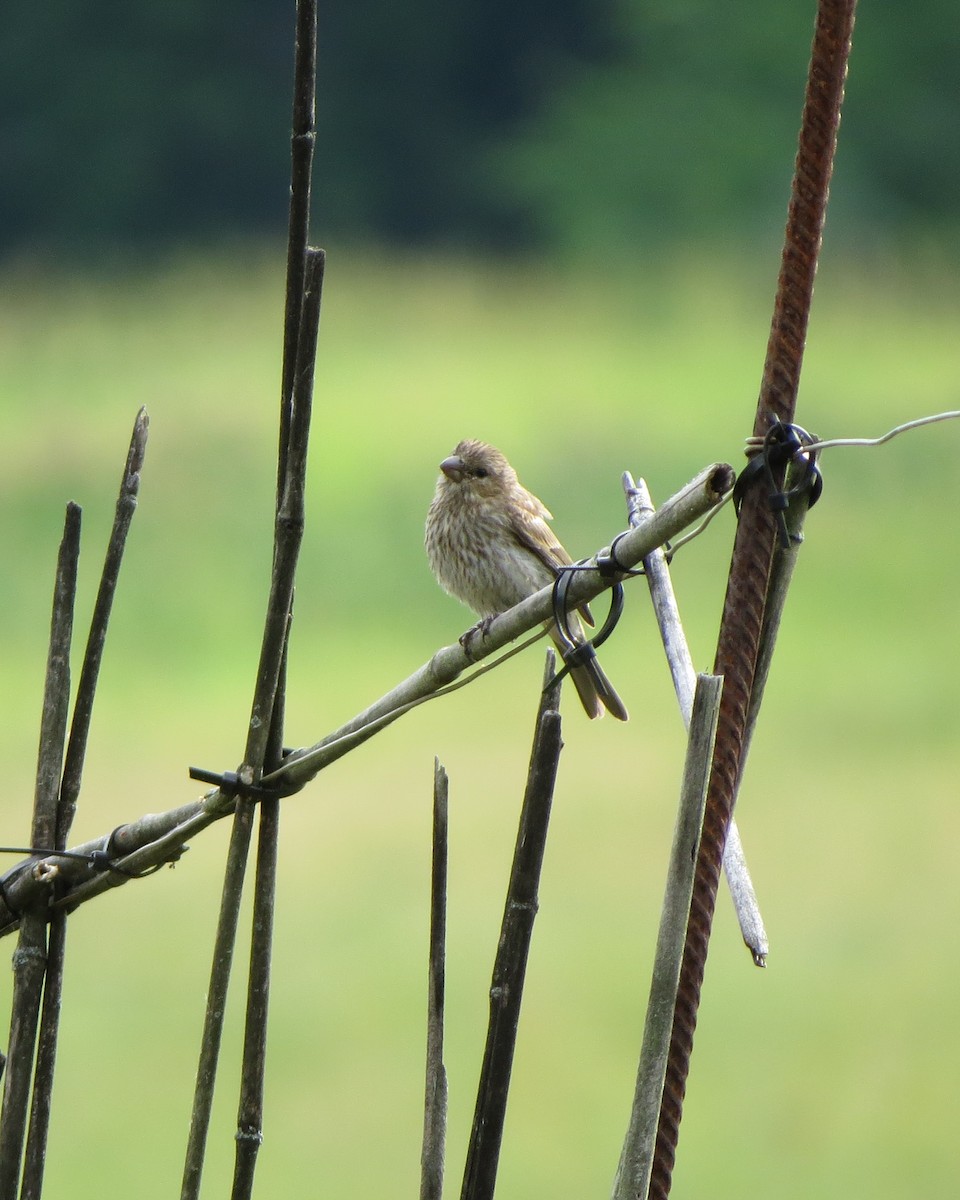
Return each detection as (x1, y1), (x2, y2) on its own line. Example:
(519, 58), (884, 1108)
(649, 0), (856, 1200)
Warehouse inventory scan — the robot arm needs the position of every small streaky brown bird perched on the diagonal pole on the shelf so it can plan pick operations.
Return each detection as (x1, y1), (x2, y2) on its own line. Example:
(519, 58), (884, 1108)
(425, 440), (626, 721)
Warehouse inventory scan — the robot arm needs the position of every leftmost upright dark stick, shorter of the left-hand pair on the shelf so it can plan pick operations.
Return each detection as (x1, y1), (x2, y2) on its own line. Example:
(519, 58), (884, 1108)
(0, 504), (80, 1200)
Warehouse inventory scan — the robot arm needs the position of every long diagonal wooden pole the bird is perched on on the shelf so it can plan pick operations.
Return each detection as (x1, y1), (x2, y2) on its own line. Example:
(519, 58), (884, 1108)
(0, 464), (733, 937)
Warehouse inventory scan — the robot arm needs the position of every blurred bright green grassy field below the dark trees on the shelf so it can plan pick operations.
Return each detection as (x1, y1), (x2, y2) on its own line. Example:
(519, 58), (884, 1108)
(0, 246), (960, 1200)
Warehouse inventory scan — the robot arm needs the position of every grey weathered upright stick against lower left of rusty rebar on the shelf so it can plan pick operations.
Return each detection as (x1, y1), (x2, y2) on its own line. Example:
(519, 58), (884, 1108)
(613, 674), (724, 1200)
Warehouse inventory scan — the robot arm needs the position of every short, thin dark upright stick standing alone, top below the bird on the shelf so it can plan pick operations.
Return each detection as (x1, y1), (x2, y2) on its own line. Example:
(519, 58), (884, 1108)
(420, 758), (448, 1200)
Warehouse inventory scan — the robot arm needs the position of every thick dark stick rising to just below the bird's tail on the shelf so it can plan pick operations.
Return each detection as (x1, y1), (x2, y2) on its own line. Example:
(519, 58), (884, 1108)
(461, 650), (563, 1200)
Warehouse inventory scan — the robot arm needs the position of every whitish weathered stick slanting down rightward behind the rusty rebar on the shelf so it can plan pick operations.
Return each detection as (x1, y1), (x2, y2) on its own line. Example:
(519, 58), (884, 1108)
(623, 472), (769, 967)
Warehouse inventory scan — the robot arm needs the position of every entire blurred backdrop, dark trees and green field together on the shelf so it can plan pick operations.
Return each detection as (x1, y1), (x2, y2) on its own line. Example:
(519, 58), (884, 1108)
(0, 4), (960, 1200)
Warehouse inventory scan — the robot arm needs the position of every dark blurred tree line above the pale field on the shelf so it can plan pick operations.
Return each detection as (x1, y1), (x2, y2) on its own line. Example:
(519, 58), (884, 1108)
(0, 0), (960, 252)
